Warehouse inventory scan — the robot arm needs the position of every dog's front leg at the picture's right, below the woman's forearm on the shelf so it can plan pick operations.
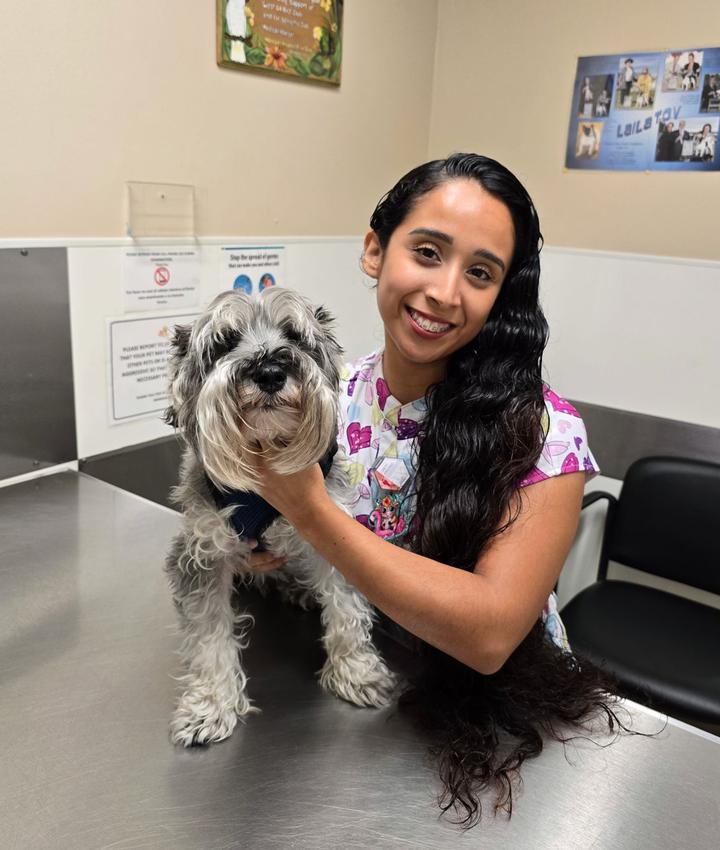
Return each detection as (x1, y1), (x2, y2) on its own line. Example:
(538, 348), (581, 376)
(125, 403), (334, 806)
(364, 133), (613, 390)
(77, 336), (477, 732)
(317, 565), (397, 708)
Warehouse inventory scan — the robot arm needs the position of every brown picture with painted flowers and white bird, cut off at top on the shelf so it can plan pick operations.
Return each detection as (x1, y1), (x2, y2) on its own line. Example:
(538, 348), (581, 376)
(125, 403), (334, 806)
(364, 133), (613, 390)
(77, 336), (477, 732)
(217, 0), (343, 85)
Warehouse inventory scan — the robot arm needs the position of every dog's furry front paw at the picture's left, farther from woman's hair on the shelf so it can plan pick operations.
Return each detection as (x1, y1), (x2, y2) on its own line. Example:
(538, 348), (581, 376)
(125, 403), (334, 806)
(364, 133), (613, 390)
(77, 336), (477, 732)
(170, 691), (260, 747)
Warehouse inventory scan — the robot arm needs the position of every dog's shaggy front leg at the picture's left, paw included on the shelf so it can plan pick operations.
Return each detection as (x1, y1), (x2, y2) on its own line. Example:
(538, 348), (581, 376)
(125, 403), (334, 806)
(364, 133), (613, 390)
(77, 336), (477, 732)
(166, 534), (258, 747)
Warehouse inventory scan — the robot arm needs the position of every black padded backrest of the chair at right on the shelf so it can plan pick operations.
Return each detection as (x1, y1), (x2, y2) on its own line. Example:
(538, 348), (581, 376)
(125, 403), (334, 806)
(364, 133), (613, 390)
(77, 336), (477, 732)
(605, 457), (720, 593)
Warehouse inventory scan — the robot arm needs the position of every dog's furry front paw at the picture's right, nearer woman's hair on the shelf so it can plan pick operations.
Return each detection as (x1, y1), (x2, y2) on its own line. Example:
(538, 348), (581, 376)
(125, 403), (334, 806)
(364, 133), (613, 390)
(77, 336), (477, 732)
(320, 652), (397, 708)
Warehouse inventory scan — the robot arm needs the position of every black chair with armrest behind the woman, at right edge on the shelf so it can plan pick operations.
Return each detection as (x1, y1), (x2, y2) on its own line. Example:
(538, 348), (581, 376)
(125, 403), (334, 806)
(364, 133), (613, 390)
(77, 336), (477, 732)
(561, 457), (720, 724)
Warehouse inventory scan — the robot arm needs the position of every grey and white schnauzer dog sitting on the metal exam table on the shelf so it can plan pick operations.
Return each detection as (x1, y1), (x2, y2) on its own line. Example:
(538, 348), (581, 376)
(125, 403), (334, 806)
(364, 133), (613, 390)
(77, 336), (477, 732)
(166, 288), (395, 746)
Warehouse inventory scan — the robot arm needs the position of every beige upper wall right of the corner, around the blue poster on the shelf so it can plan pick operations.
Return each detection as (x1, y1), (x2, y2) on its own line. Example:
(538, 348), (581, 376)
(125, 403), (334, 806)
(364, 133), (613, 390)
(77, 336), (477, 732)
(429, 0), (720, 259)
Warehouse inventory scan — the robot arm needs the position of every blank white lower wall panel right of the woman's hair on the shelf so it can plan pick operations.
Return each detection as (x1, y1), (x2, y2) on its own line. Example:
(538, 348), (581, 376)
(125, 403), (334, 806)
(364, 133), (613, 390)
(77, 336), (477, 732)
(542, 248), (720, 430)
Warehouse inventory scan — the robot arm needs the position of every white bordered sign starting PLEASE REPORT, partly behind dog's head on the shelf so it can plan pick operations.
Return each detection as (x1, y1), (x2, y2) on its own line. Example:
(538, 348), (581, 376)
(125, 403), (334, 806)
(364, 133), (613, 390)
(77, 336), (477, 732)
(108, 314), (197, 423)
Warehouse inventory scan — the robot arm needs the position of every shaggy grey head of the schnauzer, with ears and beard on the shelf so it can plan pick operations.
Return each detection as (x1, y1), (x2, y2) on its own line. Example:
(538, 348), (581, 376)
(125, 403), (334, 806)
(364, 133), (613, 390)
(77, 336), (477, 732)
(165, 287), (342, 490)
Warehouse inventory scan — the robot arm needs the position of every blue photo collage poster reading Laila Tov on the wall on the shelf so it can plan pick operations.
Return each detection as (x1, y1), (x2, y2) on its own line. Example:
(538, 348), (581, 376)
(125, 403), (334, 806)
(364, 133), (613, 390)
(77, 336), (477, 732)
(565, 47), (720, 171)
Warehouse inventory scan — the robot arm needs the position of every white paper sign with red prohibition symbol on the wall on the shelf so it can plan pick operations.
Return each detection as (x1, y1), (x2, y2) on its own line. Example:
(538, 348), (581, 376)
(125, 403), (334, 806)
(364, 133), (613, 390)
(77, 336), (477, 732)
(124, 247), (200, 312)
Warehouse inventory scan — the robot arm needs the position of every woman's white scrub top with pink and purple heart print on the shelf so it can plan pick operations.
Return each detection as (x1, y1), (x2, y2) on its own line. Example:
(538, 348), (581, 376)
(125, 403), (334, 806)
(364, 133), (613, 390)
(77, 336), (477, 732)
(338, 351), (599, 649)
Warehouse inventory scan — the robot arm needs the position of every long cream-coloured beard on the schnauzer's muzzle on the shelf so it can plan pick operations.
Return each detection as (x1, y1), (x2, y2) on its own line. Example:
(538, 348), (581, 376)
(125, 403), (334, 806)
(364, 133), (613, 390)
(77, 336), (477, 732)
(191, 363), (337, 490)
